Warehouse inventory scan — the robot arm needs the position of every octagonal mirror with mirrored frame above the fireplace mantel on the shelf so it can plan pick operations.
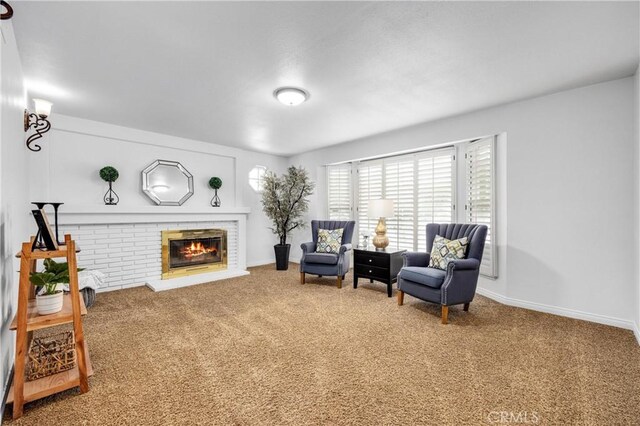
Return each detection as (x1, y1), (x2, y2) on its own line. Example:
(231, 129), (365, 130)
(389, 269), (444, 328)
(142, 160), (193, 206)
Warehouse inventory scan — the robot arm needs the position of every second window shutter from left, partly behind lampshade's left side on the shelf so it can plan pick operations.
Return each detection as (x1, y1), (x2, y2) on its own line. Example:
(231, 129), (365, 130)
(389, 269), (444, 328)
(354, 161), (382, 240)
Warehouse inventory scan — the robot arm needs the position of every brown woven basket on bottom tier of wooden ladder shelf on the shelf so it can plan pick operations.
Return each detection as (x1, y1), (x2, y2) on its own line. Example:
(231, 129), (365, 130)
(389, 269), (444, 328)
(27, 331), (76, 381)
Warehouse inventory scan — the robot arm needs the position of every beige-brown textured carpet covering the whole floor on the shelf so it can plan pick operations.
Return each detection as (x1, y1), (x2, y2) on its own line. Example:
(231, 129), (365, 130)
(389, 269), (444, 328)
(4, 264), (640, 425)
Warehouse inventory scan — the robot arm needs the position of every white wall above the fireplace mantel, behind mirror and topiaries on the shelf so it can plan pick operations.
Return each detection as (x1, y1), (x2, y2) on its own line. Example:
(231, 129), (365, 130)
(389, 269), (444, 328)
(30, 113), (287, 266)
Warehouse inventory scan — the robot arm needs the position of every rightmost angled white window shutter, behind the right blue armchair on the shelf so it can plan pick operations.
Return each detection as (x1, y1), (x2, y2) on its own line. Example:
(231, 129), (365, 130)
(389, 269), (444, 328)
(465, 137), (497, 278)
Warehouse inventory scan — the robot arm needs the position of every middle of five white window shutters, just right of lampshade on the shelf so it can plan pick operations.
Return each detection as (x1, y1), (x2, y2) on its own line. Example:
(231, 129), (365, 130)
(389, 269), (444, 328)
(384, 155), (415, 251)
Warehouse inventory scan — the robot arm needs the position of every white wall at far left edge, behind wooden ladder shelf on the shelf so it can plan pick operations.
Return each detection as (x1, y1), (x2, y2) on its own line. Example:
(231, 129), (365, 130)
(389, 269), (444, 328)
(0, 21), (32, 413)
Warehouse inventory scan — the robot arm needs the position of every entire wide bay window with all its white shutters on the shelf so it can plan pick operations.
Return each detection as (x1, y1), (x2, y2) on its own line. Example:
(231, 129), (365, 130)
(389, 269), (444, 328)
(327, 137), (498, 278)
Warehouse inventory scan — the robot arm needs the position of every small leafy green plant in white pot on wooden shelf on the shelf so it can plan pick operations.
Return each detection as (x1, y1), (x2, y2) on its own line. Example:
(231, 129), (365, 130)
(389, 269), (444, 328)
(29, 259), (82, 315)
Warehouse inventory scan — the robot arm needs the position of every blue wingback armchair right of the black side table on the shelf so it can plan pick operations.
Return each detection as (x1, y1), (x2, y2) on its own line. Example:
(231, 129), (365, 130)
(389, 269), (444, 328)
(398, 223), (487, 324)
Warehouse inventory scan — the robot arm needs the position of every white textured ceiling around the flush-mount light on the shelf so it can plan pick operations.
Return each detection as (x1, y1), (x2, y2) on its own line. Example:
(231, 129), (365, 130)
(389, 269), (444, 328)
(12, 2), (639, 155)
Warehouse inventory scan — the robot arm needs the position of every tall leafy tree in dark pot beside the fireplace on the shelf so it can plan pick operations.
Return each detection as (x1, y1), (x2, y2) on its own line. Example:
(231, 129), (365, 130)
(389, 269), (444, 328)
(262, 166), (315, 271)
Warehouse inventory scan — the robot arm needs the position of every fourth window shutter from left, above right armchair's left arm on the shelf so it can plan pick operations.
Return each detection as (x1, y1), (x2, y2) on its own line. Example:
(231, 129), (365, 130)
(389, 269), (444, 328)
(416, 148), (456, 252)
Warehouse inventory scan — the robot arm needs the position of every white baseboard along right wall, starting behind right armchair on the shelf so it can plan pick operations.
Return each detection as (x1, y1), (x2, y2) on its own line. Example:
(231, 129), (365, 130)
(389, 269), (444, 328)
(476, 288), (640, 332)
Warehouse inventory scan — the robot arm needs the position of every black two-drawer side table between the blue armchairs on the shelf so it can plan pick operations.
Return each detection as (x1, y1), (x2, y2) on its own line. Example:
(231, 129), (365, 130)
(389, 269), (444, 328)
(353, 249), (406, 297)
